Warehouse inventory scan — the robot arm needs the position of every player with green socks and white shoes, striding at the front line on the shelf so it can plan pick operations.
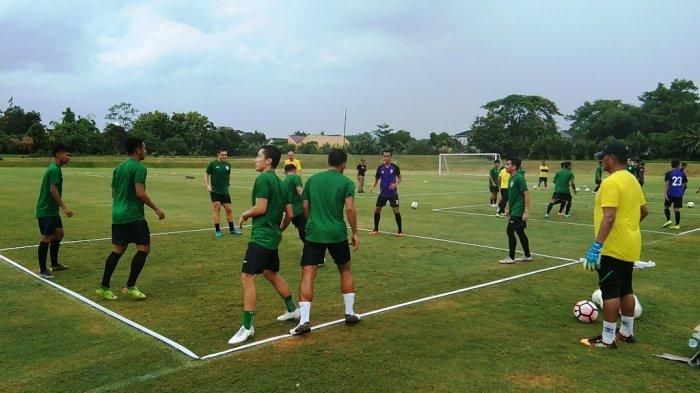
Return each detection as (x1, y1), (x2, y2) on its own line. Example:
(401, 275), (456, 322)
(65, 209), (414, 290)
(228, 145), (299, 345)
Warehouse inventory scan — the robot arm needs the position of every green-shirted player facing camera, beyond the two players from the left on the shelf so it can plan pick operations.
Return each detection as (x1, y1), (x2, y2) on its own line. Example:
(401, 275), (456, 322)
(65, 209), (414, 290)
(204, 147), (241, 239)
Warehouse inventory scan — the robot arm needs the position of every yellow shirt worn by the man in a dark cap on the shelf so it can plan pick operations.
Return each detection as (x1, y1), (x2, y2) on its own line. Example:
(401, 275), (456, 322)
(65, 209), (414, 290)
(593, 170), (647, 263)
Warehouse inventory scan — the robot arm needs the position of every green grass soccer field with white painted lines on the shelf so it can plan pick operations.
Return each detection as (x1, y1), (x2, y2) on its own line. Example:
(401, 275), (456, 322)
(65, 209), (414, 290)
(0, 159), (700, 392)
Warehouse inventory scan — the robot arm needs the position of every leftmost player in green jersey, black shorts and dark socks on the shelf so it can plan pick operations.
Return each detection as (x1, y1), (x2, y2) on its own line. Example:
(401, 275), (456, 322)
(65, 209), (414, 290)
(36, 144), (73, 280)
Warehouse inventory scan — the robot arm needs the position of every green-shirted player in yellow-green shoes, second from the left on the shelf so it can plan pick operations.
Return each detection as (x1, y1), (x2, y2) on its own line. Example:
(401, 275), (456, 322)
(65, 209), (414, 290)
(95, 137), (165, 300)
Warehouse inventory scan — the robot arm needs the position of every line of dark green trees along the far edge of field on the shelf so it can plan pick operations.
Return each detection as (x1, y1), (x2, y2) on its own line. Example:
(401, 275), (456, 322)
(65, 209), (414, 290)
(0, 79), (700, 159)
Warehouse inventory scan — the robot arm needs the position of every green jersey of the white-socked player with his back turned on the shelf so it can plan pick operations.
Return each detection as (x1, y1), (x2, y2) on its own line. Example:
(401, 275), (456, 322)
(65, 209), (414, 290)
(301, 169), (355, 244)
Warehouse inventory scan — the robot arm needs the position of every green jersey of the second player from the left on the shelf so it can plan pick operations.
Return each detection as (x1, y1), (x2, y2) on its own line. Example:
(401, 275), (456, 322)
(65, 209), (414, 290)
(112, 158), (148, 224)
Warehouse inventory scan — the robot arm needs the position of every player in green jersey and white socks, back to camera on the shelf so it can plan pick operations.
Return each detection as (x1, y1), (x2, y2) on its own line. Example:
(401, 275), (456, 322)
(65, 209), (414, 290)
(289, 149), (360, 335)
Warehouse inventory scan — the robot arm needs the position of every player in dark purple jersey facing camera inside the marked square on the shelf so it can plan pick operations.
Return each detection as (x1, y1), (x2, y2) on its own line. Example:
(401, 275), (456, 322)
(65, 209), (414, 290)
(369, 150), (403, 236)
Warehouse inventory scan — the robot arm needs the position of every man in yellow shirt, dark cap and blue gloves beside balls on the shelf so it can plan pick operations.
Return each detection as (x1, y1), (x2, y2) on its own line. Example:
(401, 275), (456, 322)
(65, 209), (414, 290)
(581, 142), (649, 349)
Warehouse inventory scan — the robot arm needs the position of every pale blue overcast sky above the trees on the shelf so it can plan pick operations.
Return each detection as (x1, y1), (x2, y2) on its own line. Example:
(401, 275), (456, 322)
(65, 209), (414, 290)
(0, 0), (700, 138)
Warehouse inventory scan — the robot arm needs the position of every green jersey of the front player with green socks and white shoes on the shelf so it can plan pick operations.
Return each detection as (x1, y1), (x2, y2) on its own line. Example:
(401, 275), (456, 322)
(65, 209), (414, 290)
(250, 171), (290, 250)
